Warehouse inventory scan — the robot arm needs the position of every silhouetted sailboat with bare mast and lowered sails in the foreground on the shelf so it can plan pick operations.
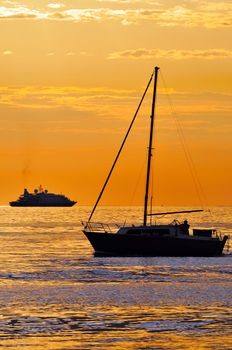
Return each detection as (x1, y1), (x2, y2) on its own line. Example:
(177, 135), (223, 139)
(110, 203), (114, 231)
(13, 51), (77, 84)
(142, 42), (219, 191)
(83, 67), (228, 256)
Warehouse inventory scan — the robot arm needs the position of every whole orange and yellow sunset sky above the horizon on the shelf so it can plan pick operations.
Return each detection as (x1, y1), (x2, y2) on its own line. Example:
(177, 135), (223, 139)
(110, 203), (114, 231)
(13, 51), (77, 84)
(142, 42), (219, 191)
(0, 0), (232, 206)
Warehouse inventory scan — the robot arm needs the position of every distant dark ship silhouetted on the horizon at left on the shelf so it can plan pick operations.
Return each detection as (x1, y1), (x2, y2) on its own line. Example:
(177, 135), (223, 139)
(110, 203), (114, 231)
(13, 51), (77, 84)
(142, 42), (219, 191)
(9, 186), (77, 207)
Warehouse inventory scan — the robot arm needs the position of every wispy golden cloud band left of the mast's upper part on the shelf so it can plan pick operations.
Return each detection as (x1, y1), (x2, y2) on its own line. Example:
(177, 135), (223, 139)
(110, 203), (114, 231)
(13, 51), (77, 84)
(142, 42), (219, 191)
(0, 86), (137, 115)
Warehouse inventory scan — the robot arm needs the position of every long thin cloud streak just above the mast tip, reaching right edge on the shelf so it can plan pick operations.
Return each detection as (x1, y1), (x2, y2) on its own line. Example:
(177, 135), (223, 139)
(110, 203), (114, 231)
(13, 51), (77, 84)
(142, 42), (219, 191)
(108, 48), (232, 60)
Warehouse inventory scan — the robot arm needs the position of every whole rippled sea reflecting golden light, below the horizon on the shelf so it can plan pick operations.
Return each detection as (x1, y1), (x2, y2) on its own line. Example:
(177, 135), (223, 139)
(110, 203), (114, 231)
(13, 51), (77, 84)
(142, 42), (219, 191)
(0, 206), (232, 350)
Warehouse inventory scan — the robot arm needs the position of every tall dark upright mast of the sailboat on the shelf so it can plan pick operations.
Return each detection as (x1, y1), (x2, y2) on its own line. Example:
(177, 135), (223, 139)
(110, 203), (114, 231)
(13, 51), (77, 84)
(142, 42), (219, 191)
(143, 67), (159, 226)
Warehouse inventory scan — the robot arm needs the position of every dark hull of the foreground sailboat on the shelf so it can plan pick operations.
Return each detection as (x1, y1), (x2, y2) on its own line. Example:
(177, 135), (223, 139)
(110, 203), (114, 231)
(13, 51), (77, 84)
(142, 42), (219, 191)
(84, 231), (227, 256)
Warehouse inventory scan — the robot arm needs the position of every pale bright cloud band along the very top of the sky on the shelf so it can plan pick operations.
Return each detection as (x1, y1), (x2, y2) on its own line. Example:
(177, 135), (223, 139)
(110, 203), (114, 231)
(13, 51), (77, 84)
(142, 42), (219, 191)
(0, 0), (232, 28)
